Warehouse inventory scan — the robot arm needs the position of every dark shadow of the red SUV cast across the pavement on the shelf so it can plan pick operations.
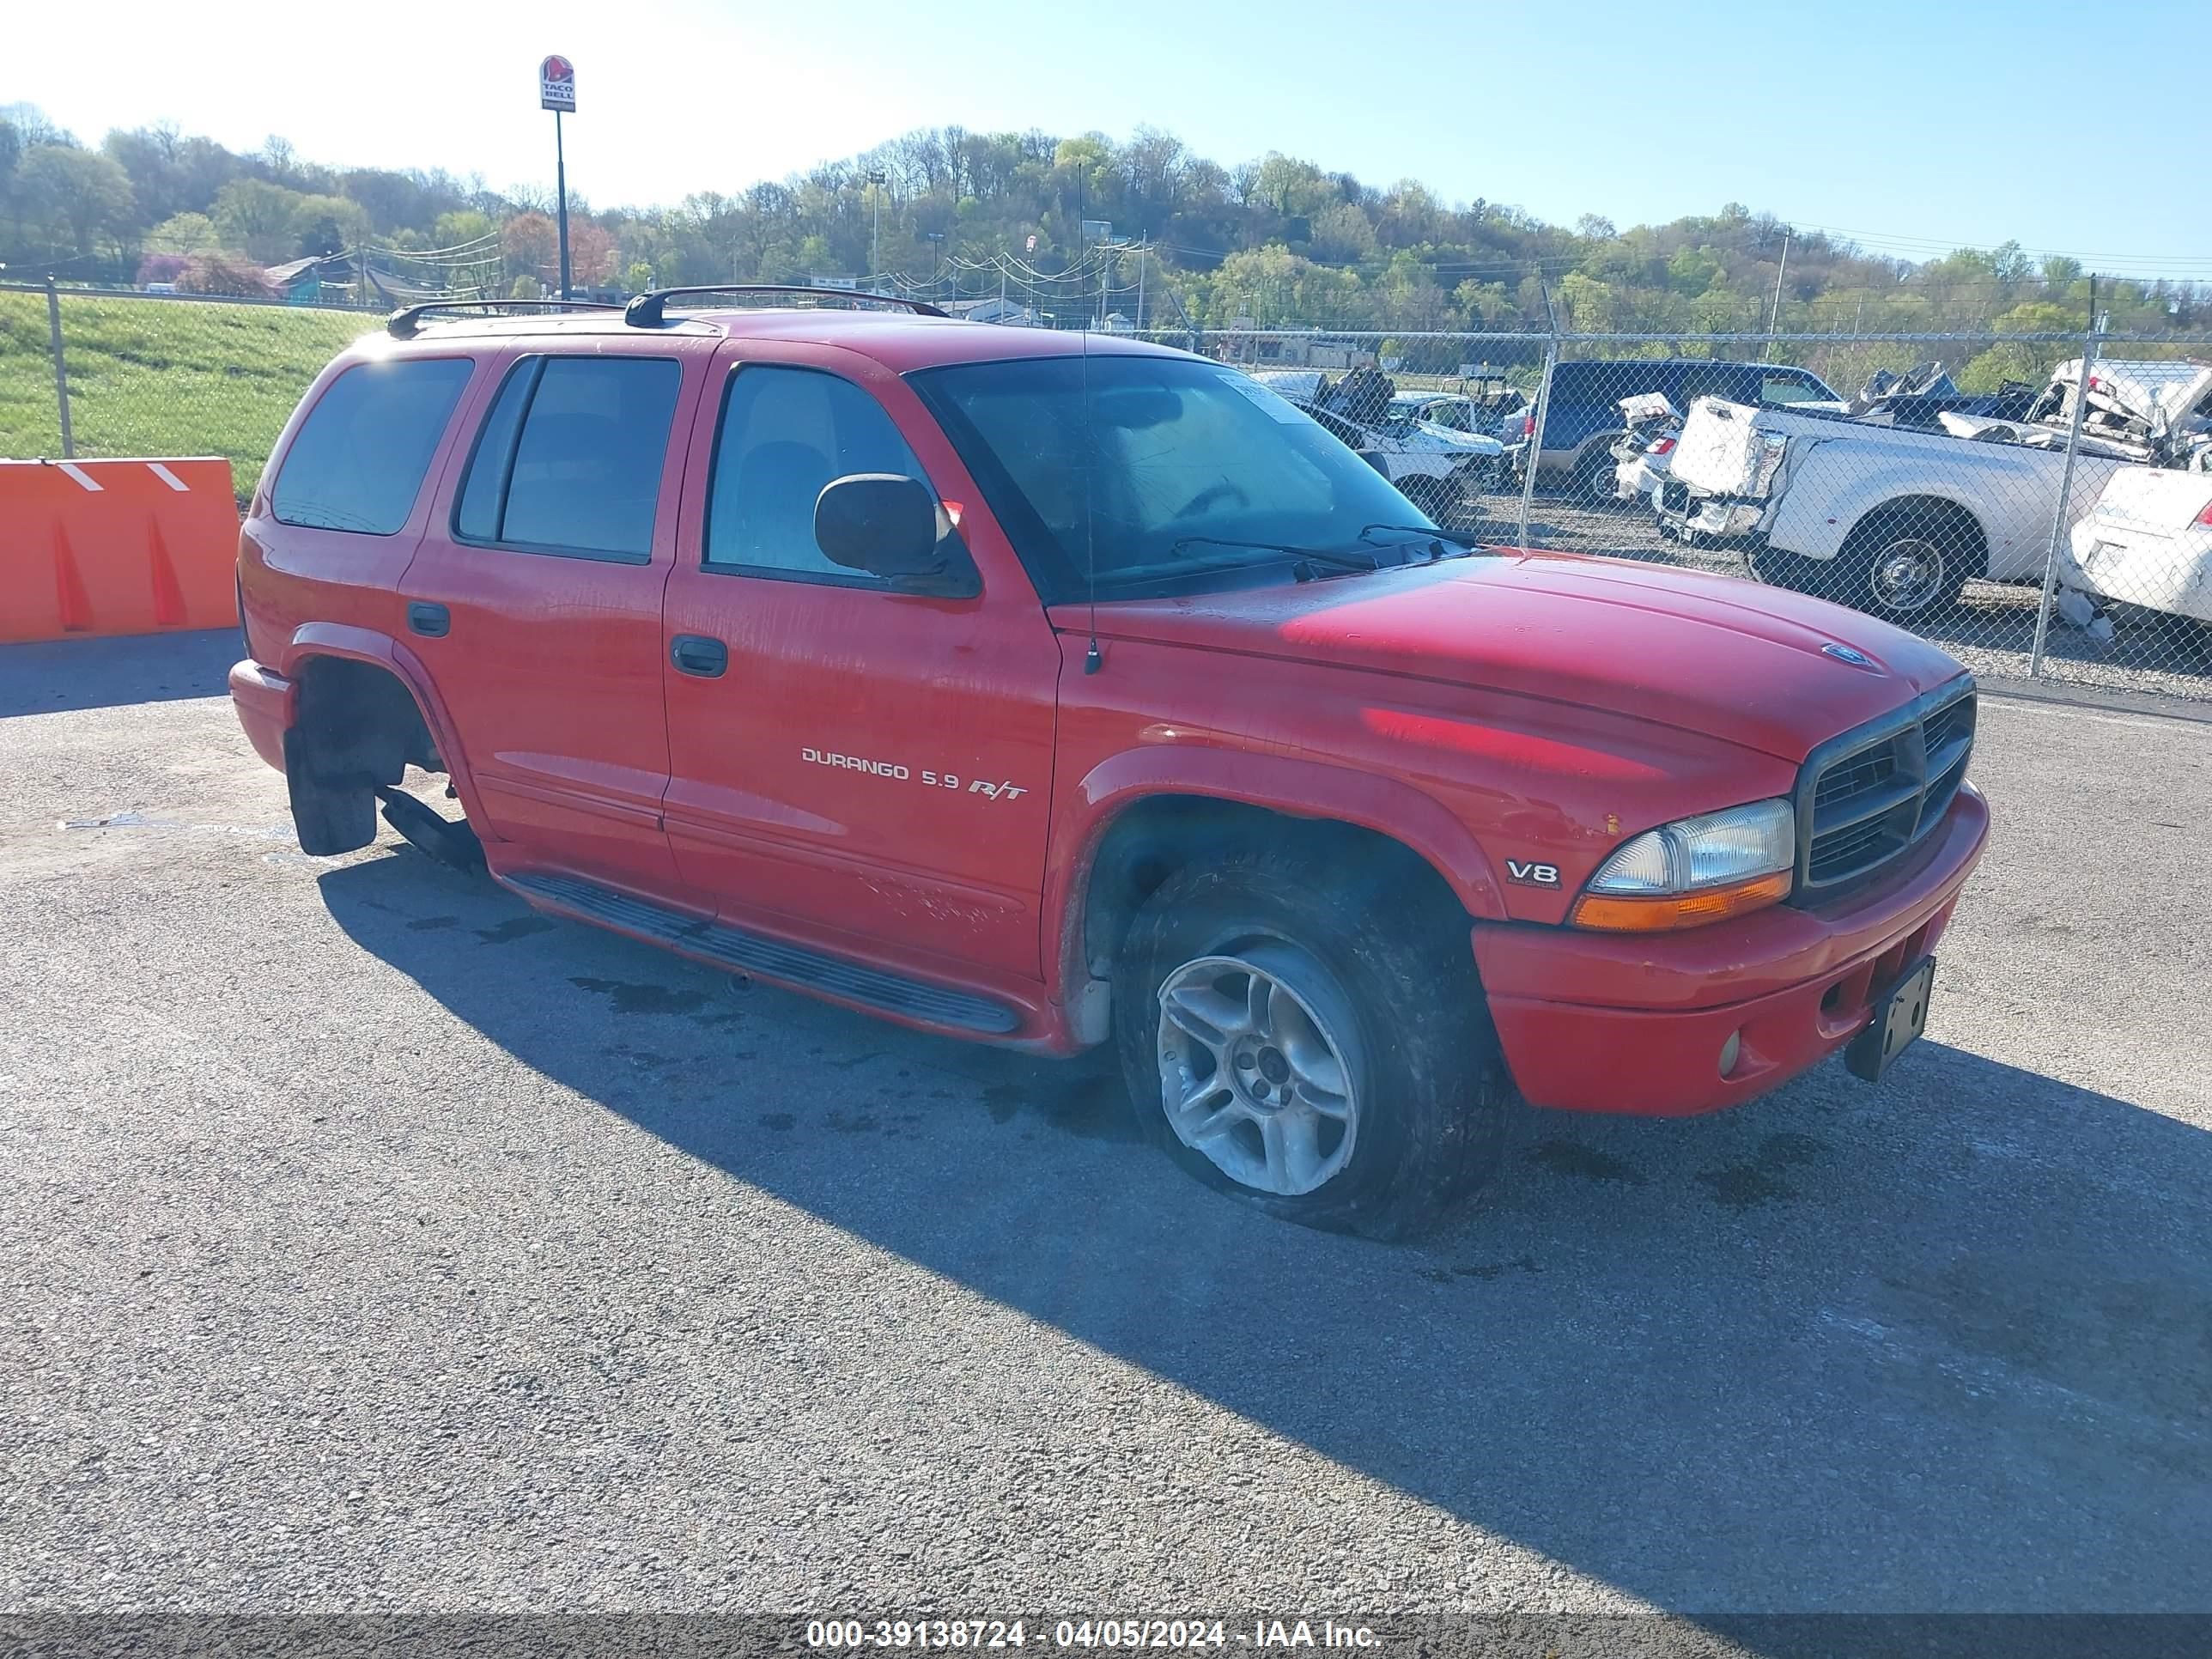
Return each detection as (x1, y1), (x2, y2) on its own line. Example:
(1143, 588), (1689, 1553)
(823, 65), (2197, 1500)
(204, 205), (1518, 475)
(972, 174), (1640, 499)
(321, 852), (2212, 1627)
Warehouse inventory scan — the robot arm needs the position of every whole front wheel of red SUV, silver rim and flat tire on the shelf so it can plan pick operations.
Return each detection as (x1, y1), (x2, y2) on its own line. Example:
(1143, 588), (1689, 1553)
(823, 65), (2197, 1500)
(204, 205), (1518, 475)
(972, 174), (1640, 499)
(1115, 854), (1513, 1237)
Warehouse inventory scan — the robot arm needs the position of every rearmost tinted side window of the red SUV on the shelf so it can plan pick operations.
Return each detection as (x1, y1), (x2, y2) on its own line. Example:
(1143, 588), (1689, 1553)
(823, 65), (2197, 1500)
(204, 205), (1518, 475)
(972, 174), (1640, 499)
(270, 356), (476, 535)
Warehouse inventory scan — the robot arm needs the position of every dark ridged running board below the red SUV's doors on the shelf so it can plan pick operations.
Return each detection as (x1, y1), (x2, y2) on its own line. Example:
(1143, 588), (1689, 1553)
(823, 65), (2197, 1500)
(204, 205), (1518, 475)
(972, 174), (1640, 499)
(504, 869), (1022, 1037)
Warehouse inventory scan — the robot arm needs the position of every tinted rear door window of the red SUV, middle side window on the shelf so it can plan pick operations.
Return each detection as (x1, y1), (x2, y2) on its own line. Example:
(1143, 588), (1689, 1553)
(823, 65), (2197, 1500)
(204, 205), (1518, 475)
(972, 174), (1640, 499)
(453, 356), (684, 564)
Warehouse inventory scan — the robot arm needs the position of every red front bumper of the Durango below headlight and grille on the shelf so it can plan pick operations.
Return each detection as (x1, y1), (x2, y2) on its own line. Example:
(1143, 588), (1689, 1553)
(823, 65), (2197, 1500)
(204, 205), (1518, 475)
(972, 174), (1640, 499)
(1474, 783), (1989, 1117)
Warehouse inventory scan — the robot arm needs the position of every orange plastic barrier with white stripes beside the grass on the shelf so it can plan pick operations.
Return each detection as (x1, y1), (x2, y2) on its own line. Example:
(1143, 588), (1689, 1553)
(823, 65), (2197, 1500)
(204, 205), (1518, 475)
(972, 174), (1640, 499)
(0, 460), (239, 644)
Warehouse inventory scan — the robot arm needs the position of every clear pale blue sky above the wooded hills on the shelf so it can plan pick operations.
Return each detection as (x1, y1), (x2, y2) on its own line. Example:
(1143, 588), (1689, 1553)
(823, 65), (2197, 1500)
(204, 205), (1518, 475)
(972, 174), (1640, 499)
(0, 0), (2212, 281)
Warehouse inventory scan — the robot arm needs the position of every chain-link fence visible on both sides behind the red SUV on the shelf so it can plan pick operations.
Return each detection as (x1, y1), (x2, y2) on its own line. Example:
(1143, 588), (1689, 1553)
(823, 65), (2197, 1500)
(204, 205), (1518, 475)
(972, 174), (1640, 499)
(0, 285), (2212, 699)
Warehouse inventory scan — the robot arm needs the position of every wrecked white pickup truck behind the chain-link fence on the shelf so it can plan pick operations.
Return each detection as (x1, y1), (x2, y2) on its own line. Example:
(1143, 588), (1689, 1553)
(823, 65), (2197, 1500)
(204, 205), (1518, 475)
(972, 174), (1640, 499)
(1659, 362), (2194, 623)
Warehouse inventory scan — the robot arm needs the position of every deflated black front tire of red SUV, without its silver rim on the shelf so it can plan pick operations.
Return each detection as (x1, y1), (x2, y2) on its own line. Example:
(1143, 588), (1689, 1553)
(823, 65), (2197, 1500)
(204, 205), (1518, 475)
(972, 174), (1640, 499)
(1113, 852), (1513, 1239)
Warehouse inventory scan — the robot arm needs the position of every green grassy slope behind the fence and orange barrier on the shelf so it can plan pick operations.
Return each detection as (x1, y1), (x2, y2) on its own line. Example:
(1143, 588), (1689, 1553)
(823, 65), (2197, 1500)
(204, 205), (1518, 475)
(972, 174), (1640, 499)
(0, 292), (378, 500)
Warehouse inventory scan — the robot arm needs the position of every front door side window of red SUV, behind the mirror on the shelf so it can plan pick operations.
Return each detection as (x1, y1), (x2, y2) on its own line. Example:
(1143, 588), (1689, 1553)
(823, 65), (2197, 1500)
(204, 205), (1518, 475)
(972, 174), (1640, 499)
(703, 362), (929, 584)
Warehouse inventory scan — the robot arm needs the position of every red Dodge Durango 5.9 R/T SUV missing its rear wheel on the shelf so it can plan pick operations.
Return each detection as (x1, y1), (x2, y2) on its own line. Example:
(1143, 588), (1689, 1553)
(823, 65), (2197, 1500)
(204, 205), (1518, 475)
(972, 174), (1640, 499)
(230, 289), (1989, 1234)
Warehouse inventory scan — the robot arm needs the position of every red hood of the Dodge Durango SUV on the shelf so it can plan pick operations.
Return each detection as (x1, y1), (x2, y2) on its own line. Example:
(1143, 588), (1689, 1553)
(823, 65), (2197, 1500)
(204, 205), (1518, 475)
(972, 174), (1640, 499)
(1053, 553), (1964, 763)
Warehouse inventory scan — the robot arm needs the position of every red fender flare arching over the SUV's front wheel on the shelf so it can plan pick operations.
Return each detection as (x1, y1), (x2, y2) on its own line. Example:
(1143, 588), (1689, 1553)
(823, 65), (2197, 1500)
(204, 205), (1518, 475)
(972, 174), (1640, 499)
(1042, 744), (1506, 1000)
